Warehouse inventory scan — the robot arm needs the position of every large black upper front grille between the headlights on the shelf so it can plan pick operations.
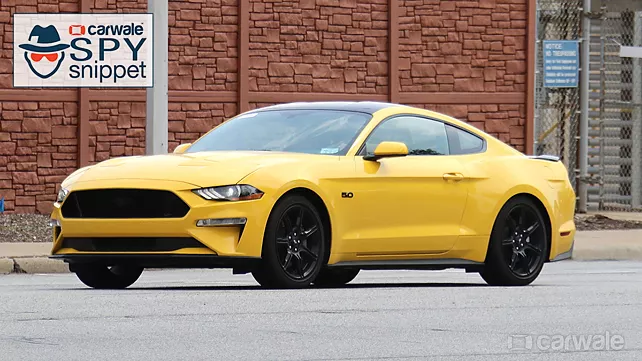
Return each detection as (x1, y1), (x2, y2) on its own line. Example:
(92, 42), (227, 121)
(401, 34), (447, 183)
(62, 189), (189, 218)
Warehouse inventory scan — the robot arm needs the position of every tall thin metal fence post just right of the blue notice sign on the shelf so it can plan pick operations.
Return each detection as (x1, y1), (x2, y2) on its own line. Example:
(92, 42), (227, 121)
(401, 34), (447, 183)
(577, 0), (591, 213)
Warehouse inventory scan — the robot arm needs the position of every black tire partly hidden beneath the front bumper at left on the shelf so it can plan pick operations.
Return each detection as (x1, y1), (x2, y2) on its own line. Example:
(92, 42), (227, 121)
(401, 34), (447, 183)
(74, 264), (143, 289)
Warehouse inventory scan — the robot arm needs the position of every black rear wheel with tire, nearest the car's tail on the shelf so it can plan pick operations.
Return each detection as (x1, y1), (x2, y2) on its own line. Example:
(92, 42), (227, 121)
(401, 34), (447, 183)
(480, 196), (550, 286)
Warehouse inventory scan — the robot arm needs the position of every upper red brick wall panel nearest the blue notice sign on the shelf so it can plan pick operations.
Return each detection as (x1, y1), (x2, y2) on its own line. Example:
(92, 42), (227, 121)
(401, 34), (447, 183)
(399, 0), (527, 92)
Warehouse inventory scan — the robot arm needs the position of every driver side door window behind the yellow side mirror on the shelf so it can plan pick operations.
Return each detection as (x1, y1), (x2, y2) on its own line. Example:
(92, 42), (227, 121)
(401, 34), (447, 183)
(361, 116), (450, 155)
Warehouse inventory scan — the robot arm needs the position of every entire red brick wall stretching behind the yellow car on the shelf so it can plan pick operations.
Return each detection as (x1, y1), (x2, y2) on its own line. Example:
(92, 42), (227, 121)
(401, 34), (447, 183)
(0, 0), (528, 213)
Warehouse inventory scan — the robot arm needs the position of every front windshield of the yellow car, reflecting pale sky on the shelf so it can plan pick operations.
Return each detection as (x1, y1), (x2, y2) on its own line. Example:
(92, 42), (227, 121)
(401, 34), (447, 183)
(187, 109), (372, 155)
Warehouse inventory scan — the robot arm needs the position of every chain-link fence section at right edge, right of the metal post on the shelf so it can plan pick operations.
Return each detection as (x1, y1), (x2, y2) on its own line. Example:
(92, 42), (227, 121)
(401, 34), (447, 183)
(588, 7), (642, 211)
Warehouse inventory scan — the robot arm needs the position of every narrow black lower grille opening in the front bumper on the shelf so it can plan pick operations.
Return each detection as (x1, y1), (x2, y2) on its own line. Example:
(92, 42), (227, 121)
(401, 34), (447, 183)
(62, 237), (207, 252)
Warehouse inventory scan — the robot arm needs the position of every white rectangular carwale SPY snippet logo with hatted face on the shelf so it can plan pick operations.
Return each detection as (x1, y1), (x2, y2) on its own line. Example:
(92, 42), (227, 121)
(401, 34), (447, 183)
(13, 14), (153, 88)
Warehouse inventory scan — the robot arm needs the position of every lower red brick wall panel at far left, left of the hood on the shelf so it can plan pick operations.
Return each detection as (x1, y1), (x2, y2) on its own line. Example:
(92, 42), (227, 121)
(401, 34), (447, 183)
(0, 102), (78, 212)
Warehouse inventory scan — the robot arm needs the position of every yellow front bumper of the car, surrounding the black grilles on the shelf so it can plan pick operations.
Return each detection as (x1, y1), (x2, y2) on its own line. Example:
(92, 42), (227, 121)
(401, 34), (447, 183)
(51, 180), (271, 258)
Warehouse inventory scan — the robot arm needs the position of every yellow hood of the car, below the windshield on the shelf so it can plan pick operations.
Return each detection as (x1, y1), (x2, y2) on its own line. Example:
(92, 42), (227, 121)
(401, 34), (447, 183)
(66, 151), (324, 187)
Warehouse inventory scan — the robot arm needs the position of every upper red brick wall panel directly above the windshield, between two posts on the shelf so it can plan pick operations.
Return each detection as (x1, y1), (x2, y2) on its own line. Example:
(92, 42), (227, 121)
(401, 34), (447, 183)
(250, 0), (388, 94)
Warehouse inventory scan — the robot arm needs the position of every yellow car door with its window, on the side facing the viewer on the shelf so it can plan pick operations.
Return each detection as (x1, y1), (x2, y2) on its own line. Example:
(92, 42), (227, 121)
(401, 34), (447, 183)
(342, 115), (467, 256)
